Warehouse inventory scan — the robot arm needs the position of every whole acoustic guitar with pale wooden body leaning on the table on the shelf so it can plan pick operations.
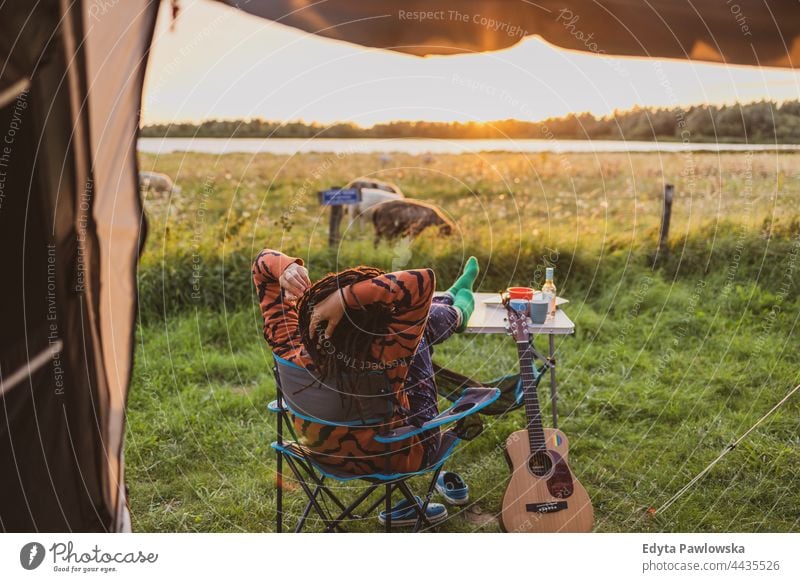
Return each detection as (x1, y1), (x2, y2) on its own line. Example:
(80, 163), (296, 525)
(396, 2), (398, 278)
(502, 308), (594, 532)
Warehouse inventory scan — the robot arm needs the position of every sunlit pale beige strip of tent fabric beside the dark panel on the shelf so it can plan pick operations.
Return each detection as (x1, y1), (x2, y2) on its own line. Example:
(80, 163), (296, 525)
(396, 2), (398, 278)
(84, 0), (156, 529)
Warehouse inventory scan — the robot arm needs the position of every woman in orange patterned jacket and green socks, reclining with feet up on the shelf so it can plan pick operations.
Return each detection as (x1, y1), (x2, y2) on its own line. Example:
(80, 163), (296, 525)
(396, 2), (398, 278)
(253, 249), (478, 516)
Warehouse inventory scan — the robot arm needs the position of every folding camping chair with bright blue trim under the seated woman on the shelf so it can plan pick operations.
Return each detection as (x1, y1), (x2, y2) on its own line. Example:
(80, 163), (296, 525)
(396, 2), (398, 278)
(268, 356), (500, 533)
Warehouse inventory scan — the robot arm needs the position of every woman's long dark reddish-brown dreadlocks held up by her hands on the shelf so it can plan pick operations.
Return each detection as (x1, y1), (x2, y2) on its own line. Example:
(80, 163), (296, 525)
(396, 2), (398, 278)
(297, 266), (391, 395)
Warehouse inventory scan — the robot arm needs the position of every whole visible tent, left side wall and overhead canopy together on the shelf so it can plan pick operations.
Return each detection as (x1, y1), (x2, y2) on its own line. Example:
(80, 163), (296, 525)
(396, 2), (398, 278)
(0, 0), (800, 531)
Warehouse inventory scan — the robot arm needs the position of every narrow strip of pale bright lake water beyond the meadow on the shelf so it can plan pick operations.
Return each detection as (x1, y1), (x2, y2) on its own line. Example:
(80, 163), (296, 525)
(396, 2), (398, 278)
(138, 137), (800, 155)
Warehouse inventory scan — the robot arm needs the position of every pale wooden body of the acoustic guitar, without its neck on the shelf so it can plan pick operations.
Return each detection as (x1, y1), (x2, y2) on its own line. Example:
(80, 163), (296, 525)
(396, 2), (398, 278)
(502, 428), (594, 533)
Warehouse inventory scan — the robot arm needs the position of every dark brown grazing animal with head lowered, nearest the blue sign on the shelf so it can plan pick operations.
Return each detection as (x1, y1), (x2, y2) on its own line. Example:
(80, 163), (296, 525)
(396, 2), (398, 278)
(372, 200), (455, 245)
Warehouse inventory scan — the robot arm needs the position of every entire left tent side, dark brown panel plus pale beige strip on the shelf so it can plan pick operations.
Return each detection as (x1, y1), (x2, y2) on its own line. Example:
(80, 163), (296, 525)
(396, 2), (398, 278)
(0, 0), (158, 531)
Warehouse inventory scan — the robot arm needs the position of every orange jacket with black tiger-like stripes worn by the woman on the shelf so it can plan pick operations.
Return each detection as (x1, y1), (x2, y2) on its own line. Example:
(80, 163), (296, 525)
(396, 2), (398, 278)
(253, 249), (436, 475)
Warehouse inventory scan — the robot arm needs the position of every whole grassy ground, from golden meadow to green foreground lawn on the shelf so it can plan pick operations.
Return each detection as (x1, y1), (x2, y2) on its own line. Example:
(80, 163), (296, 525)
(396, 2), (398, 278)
(126, 153), (800, 531)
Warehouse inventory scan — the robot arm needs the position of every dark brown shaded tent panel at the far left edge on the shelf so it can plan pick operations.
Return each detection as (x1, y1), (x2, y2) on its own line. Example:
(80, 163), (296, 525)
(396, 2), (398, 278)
(0, 2), (111, 531)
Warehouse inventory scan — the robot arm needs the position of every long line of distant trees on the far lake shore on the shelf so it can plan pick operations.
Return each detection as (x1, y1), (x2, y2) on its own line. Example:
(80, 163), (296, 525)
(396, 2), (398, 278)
(141, 101), (800, 143)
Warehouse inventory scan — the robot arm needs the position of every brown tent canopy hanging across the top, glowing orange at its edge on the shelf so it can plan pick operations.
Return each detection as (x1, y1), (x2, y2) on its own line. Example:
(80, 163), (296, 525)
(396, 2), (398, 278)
(225, 0), (800, 67)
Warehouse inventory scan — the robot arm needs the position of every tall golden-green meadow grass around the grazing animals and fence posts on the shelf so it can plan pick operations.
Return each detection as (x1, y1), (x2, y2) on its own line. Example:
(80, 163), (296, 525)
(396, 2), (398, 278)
(139, 153), (800, 318)
